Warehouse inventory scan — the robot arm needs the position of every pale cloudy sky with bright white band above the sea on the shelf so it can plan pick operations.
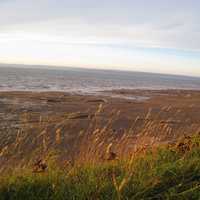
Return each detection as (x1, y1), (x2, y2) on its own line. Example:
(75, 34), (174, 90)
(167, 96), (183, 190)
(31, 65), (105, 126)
(0, 0), (200, 76)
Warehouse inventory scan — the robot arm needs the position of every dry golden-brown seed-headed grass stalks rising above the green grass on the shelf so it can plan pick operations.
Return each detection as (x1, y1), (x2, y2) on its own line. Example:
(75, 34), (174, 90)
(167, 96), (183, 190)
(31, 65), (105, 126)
(0, 104), (199, 169)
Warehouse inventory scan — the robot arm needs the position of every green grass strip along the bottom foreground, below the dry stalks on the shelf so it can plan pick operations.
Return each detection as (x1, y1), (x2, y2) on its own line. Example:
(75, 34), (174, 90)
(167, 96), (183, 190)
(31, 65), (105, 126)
(0, 135), (200, 200)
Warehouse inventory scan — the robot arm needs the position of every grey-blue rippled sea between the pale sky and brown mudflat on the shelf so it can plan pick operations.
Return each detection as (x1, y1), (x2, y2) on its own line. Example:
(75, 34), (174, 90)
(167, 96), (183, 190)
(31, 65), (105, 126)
(0, 65), (200, 93)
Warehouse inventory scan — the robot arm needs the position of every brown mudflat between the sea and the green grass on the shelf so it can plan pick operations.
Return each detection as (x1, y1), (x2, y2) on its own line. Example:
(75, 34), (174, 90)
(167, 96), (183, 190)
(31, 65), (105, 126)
(0, 90), (200, 171)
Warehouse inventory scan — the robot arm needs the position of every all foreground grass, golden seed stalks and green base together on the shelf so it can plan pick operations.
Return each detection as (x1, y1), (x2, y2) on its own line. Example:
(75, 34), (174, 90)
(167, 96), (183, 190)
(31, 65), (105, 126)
(0, 105), (200, 200)
